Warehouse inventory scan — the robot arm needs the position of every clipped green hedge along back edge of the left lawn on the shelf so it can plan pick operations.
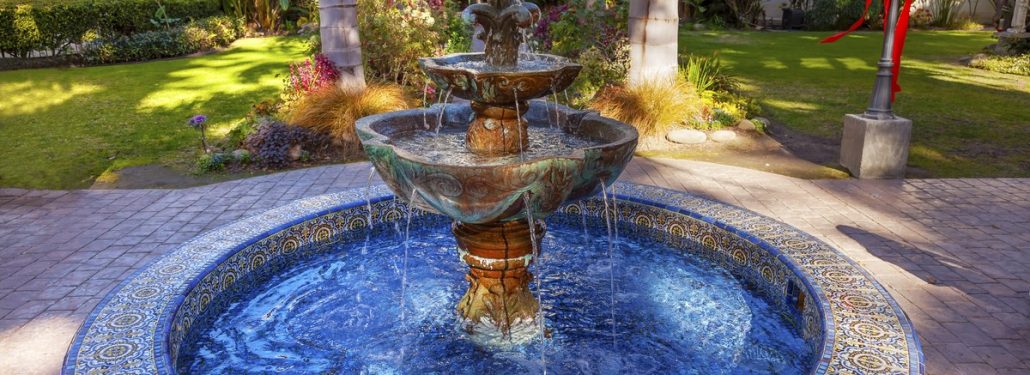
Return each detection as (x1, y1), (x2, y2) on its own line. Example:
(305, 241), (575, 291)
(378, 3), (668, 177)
(0, 0), (221, 57)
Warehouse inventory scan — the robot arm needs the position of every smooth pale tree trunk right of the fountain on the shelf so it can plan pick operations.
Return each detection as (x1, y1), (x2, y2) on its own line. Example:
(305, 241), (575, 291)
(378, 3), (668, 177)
(629, 0), (680, 84)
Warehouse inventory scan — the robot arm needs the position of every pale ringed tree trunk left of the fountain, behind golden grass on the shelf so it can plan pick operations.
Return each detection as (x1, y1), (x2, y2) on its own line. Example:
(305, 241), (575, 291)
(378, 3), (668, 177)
(318, 0), (365, 90)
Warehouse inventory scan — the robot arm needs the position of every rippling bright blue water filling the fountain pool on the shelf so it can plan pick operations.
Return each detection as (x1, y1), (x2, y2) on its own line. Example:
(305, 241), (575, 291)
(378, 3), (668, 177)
(177, 217), (812, 374)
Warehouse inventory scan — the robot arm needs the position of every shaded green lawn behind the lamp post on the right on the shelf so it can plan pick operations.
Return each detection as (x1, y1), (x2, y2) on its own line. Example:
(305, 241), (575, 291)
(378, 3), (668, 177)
(680, 32), (1030, 177)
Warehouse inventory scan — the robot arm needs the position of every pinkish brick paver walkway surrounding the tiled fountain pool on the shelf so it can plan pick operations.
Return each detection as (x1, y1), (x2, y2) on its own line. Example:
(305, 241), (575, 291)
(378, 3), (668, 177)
(0, 159), (1030, 375)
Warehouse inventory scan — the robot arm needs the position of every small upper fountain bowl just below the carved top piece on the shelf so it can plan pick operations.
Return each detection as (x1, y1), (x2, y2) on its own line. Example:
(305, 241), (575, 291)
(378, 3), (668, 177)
(418, 54), (583, 106)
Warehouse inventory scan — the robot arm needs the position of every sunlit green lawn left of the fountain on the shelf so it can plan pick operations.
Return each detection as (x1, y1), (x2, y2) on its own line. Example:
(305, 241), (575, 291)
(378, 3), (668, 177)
(0, 37), (306, 189)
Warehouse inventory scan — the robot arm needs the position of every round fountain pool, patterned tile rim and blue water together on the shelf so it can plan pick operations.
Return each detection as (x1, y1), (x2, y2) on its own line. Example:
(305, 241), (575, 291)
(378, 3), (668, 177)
(64, 184), (922, 374)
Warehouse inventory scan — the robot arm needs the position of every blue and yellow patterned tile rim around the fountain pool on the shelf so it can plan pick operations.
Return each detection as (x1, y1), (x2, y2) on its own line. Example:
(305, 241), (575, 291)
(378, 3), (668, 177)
(62, 183), (924, 374)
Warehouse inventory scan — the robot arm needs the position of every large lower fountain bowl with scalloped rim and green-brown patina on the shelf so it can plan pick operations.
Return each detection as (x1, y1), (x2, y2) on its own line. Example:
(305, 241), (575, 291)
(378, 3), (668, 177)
(356, 101), (638, 224)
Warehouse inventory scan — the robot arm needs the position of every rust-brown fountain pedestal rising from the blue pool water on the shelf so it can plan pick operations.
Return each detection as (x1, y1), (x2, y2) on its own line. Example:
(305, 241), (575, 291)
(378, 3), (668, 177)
(451, 220), (544, 341)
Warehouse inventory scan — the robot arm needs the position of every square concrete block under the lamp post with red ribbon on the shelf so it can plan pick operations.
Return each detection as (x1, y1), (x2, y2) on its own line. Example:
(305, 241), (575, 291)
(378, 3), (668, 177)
(840, 114), (912, 178)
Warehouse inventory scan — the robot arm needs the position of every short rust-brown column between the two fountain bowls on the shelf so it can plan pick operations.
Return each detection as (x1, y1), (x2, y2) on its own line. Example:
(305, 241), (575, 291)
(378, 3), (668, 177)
(466, 101), (529, 157)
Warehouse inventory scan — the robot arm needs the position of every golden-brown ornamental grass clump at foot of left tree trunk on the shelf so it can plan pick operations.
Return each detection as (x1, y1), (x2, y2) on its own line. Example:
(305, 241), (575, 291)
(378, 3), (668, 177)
(287, 84), (412, 143)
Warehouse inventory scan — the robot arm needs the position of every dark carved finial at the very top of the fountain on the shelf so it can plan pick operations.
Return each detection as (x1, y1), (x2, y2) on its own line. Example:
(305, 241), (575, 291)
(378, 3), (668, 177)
(464, 0), (540, 68)
